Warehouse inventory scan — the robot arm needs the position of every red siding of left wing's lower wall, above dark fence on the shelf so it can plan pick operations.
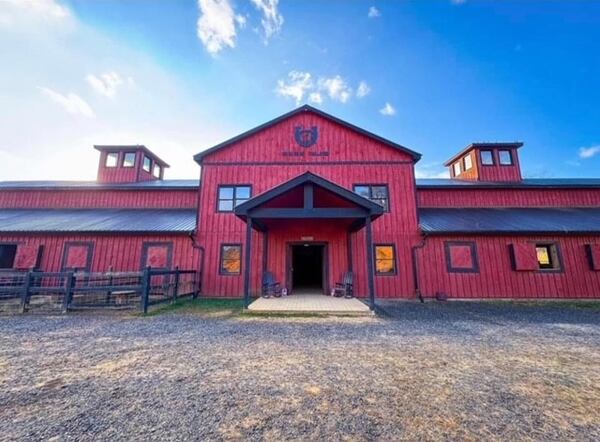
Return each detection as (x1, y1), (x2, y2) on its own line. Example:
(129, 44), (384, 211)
(0, 234), (199, 272)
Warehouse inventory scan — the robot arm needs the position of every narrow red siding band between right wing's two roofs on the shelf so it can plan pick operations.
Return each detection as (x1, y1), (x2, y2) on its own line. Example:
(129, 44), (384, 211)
(417, 188), (600, 207)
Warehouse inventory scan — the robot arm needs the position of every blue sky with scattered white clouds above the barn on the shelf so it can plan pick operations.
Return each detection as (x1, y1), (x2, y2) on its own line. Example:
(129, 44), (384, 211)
(0, 0), (600, 180)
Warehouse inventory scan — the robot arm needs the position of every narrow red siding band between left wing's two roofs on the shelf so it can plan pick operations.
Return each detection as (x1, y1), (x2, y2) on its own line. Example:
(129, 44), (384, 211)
(0, 189), (198, 209)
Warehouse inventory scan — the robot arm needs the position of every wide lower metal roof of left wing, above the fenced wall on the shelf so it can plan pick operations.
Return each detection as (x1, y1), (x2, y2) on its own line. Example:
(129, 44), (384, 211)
(0, 209), (196, 233)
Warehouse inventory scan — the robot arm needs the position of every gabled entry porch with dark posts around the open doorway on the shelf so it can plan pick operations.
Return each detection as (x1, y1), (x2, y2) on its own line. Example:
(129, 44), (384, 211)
(235, 172), (383, 309)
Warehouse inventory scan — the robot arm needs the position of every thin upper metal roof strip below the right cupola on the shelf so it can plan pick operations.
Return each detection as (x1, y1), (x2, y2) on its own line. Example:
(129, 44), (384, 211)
(417, 178), (600, 189)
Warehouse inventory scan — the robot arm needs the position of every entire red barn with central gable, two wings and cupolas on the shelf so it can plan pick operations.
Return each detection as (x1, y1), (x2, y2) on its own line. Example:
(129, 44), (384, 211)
(0, 106), (600, 308)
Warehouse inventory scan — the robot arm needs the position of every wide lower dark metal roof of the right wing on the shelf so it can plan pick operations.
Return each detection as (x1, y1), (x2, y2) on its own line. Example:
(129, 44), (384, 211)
(419, 208), (600, 234)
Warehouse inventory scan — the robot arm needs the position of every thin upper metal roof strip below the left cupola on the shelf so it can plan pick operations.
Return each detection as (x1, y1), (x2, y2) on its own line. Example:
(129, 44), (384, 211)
(0, 179), (199, 190)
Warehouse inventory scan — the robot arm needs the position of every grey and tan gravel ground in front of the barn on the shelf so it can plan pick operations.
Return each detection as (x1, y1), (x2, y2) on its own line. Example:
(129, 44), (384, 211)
(0, 303), (600, 441)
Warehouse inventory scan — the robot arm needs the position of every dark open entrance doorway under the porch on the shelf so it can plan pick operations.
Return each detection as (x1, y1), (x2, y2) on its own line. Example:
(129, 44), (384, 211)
(290, 243), (325, 294)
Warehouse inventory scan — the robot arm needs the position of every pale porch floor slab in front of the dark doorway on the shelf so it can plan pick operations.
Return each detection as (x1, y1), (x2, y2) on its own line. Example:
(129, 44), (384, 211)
(248, 294), (372, 315)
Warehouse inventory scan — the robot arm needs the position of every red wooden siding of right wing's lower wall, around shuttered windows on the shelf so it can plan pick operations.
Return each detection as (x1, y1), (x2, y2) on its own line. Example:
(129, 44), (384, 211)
(418, 236), (600, 298)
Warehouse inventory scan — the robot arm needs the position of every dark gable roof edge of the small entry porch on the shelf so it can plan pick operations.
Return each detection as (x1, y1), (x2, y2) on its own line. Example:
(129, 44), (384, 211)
(235, 172), (383, 216)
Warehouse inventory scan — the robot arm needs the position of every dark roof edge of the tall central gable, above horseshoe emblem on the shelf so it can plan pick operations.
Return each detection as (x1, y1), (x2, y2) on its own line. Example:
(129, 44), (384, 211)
(194, 104), (421, 164)
